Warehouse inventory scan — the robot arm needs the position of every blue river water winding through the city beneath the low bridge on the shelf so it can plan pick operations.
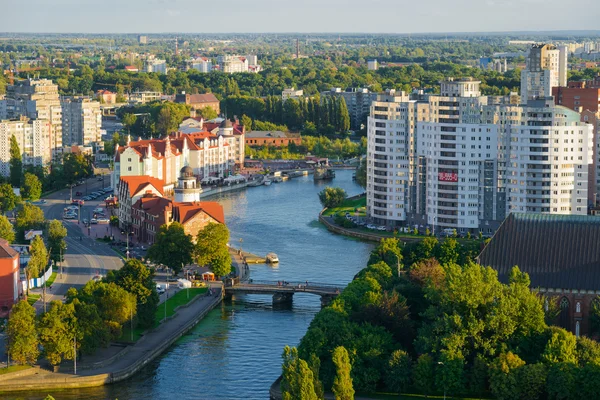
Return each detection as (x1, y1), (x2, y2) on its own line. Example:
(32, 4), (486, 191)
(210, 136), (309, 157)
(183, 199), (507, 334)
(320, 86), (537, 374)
(5, 171), (373, 400)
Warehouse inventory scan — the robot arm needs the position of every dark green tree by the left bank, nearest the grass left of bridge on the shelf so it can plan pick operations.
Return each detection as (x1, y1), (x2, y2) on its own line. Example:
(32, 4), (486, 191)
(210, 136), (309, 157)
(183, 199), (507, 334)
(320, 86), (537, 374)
(107, 258), (159, 328)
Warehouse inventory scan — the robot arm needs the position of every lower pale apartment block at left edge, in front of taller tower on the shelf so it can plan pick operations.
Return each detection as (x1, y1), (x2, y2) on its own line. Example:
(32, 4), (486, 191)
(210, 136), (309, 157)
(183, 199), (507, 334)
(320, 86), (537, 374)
(0, 116), (52, 176)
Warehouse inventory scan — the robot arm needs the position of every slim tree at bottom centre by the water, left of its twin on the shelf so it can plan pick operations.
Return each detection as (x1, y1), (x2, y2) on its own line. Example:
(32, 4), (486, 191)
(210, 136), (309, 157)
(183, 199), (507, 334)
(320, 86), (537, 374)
(281, 346), (317, 400)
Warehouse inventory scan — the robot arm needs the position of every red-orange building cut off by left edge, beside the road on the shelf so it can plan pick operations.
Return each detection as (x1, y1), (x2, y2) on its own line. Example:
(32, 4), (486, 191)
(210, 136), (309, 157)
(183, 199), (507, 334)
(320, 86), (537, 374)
(0, 239), (21, 317)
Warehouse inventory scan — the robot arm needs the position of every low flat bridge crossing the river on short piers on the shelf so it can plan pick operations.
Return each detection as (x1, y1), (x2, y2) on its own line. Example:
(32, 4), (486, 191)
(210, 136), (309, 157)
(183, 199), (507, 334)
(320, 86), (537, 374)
(224, 279), (344, 306)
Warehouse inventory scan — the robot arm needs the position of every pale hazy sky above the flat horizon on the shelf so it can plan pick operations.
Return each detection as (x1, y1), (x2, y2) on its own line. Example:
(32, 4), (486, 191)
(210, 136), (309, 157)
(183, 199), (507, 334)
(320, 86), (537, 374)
(0, 0), (600, 33)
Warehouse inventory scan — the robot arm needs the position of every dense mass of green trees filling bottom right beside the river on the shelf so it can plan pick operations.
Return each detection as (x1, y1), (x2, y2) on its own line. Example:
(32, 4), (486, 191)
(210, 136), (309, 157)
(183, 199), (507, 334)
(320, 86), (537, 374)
(298, 237), (600, 399)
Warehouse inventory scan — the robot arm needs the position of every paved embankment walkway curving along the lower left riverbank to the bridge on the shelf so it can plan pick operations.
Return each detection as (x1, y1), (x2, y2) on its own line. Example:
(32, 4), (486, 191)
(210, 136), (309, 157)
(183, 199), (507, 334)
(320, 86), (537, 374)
(0, 285), (223, 393)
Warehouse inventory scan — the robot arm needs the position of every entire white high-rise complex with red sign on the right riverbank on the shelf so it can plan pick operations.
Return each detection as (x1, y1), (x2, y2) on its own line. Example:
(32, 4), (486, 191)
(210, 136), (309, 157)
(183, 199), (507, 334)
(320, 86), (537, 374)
(367, 78), (594, 233)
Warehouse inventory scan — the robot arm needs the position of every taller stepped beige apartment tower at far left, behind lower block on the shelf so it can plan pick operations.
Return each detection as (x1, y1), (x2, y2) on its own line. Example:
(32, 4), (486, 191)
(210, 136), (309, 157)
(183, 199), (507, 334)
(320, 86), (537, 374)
(0, 79), (63, 158)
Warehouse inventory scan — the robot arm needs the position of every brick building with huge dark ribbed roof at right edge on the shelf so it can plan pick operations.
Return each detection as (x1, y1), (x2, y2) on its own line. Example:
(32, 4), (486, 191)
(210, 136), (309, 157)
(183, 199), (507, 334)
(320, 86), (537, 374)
(477, 213), (600, 336)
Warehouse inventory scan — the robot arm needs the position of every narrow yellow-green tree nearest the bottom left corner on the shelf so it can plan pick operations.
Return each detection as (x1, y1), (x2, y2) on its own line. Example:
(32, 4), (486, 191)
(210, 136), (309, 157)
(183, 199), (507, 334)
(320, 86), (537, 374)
(6, 300), (40, 364)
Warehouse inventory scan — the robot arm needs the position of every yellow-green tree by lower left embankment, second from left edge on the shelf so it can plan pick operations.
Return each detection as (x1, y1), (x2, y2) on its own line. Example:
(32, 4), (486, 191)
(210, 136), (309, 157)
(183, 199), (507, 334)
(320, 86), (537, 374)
(39, 300), (82, 365)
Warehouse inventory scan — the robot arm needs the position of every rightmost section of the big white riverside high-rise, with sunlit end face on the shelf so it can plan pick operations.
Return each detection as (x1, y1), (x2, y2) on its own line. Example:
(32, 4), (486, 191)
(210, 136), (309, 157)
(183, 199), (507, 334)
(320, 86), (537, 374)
(506, 99), (594, 215)
